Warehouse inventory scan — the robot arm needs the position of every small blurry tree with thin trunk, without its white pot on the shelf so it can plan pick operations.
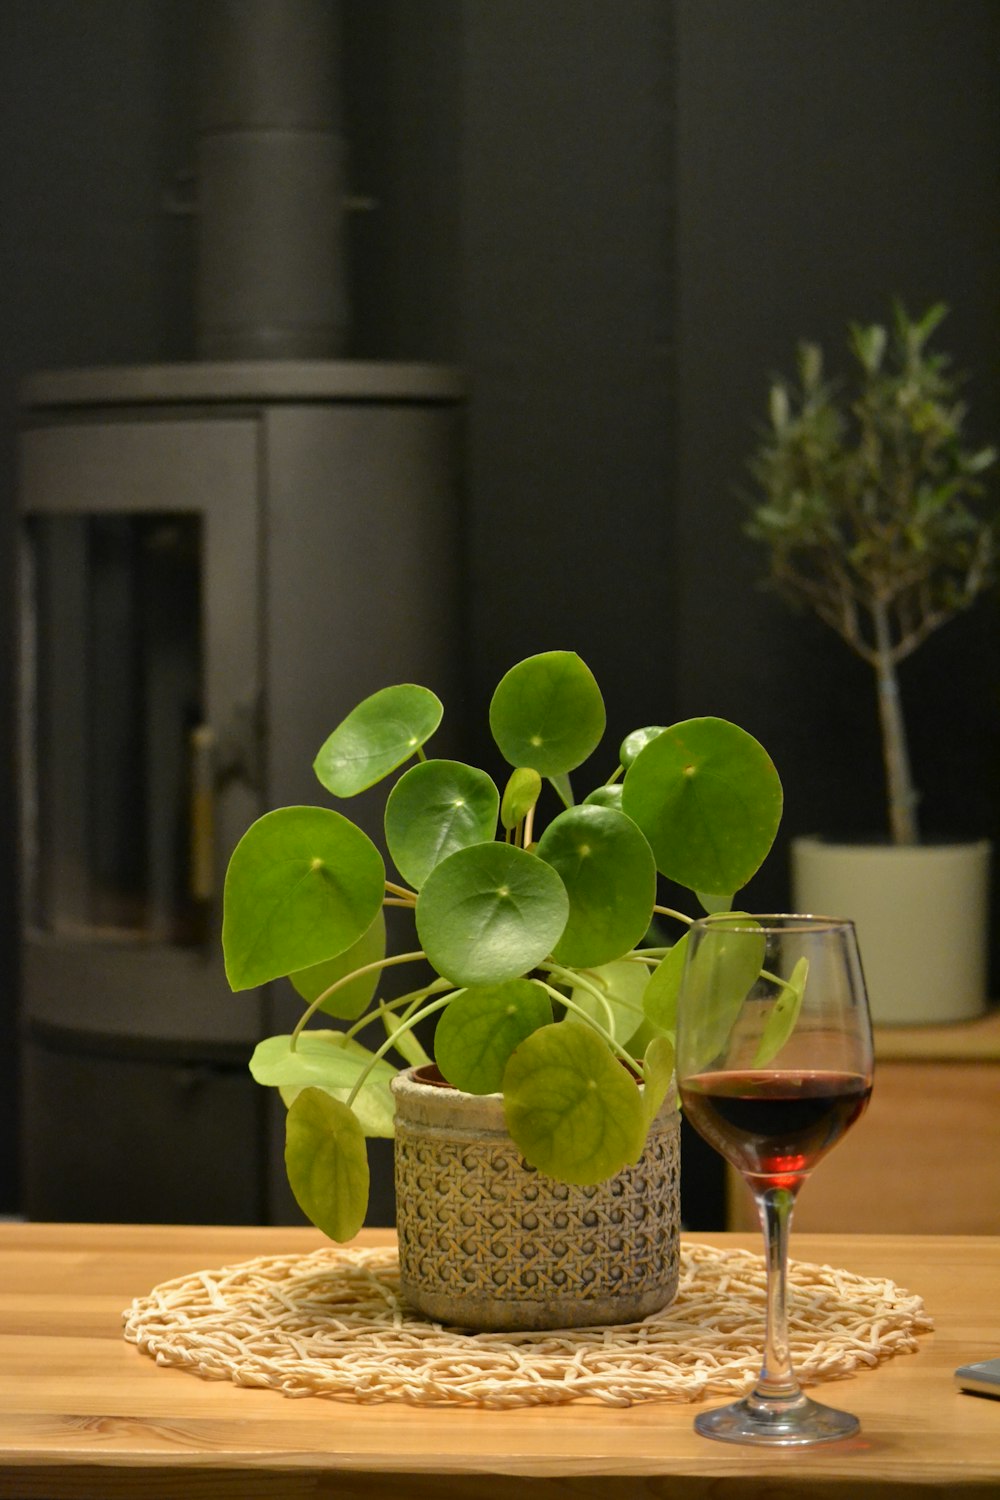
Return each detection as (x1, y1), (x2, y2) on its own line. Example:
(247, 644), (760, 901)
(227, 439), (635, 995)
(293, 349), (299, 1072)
(747, 303), (997, 845)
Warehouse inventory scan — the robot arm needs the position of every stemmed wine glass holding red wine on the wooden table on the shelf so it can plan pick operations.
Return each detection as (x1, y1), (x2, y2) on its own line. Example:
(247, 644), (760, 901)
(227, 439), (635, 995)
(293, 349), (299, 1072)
(676, 914), (873, 1445)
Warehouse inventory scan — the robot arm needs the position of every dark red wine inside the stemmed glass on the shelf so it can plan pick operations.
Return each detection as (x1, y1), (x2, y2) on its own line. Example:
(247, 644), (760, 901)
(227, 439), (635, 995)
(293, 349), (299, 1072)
(681, 1068), (871, 1188)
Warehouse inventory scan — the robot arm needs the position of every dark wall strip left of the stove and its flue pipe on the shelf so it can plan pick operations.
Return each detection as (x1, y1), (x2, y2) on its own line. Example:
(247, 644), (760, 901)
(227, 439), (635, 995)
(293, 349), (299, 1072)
(0, 0), (200, 1212)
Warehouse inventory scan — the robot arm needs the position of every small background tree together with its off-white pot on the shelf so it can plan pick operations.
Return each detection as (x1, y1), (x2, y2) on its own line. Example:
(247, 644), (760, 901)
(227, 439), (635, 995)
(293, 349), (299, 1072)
(747, 303), (997, 1023)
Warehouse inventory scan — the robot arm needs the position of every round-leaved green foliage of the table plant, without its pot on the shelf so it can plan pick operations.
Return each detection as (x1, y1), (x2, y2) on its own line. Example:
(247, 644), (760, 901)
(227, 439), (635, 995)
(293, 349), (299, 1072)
(222, 651), (781, 1241)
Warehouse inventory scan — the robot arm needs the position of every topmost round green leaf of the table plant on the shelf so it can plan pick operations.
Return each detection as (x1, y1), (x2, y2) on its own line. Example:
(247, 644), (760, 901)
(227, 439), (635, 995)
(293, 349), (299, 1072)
(490, 651), (606, 777)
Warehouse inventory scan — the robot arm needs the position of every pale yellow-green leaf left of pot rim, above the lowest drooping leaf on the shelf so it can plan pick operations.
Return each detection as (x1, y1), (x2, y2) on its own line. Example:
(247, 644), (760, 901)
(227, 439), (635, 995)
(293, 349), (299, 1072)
(250, 1031), (396, 1136)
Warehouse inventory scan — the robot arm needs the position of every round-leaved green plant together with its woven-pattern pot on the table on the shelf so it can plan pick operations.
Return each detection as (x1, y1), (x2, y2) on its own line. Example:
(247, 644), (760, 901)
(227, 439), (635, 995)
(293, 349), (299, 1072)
(223, 651), (781, 1328)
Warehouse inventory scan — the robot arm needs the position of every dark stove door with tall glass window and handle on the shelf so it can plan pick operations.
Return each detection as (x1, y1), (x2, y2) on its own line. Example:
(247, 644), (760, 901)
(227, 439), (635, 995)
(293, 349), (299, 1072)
(21, 419), (262, 1047)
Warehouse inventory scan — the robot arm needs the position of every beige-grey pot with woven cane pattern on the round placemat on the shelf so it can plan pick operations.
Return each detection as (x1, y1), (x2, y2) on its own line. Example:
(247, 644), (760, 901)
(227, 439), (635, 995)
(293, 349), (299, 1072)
(393, 1068), (681, 1331)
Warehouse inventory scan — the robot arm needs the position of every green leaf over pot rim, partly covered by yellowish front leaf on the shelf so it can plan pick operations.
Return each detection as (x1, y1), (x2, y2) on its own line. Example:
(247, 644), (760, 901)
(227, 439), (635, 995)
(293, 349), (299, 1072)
(435, 980), (552, 1094)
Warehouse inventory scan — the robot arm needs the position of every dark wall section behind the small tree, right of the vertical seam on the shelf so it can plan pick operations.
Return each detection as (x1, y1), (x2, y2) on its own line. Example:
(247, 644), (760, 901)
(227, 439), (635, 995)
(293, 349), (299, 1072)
(673, 0), (1000, 899)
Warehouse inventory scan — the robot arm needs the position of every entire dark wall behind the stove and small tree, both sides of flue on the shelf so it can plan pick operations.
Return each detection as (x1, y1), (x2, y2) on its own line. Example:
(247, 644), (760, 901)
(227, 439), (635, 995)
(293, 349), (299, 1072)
(0, 0), (1000, 1208)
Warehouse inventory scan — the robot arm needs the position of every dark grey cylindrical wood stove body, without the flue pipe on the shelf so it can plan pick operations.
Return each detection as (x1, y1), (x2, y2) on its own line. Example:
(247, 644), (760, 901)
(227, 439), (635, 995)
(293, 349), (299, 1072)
(19, 359), (462, 1223)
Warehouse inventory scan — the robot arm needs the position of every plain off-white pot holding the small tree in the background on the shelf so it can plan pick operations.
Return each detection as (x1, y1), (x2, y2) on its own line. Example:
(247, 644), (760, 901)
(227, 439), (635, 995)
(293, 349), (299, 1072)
(792, 839), (991, 1026)
